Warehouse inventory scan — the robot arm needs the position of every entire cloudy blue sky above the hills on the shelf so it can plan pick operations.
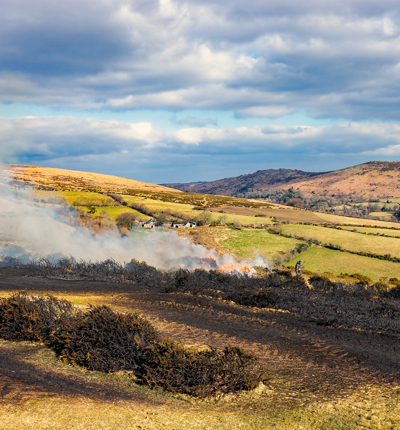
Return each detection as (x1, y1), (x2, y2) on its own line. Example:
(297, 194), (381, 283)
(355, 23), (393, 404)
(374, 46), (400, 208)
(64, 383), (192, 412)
(0, 0), (400, 183)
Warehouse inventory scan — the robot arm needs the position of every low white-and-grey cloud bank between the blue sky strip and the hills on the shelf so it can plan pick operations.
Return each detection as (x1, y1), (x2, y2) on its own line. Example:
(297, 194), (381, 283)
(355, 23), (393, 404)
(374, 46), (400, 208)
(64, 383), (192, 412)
(0, 117), (400, 182)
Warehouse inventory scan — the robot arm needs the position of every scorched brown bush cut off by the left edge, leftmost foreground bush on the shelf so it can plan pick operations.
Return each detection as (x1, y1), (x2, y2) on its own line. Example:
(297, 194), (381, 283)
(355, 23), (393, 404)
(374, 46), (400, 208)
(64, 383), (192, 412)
(0, 293), (73, 341)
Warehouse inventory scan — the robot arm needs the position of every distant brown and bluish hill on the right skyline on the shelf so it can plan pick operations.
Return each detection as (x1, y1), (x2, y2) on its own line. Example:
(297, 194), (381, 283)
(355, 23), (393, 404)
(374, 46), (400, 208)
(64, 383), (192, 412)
(165, 161), (400, 198)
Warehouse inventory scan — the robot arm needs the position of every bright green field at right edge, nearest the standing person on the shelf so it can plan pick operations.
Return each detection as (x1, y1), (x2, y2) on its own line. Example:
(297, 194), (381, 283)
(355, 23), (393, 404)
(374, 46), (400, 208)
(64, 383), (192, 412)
(285, 247), (400, 281)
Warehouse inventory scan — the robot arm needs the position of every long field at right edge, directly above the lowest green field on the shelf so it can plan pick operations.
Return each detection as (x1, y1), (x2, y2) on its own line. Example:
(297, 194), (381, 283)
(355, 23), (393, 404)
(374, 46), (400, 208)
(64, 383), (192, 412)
(282, 225), (400, 257)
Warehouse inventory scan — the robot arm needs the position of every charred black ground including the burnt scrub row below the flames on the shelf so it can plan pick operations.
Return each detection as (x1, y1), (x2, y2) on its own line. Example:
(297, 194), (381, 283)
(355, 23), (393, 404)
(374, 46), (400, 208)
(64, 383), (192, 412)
(0, 265), (400, 416)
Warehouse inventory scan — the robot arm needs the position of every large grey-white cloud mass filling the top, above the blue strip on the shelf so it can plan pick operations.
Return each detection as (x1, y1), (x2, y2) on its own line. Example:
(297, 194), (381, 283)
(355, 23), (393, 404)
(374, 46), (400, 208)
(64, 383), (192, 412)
(0, 0), (400, 120)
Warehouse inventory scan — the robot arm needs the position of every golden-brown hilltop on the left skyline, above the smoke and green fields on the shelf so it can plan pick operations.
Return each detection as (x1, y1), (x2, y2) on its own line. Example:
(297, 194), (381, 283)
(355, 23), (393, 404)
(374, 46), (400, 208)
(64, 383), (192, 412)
(3, 164), (176, 192)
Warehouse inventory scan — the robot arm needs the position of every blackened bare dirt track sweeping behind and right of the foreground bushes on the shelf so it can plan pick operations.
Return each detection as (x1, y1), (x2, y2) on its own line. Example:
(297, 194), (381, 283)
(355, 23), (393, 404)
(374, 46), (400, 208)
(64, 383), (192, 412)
(0, 269), (400, 401)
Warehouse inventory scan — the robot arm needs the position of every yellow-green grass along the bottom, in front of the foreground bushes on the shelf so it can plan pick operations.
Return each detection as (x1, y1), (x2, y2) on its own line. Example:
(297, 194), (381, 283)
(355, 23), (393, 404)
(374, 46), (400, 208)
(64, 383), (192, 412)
(0, 341), (400, 430)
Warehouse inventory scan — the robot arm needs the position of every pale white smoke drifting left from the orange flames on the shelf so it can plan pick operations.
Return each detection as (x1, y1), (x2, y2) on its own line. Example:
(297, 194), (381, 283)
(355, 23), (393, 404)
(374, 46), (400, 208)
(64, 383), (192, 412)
(0, 169), (268, 269)
